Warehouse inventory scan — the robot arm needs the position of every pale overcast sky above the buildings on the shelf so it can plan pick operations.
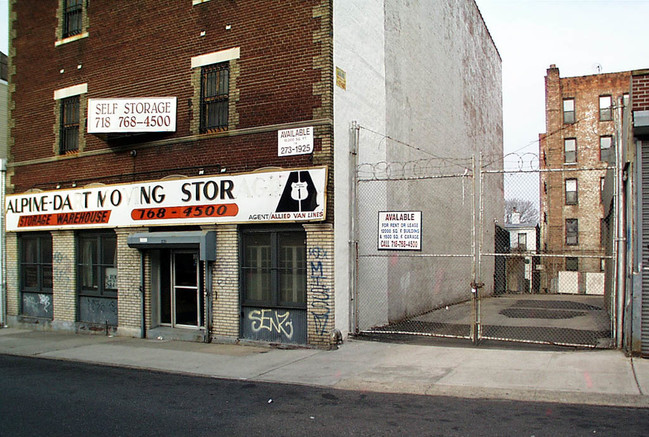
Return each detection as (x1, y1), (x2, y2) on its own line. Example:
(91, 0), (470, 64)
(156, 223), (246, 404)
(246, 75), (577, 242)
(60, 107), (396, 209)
(0, 0), (649, 160)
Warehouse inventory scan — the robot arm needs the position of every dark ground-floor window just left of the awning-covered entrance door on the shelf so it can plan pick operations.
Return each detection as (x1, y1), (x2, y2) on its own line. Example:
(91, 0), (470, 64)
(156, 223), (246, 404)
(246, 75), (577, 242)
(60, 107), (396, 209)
(77, 232), (117, 297)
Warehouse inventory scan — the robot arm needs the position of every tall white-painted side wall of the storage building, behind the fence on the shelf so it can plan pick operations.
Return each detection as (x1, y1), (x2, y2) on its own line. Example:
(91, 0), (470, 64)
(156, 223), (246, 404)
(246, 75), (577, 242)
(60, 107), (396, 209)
(333, 0), (504, 333)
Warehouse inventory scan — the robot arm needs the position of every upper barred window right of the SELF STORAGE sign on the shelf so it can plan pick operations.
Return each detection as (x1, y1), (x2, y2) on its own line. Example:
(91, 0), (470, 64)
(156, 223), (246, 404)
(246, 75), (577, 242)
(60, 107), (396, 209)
(201, 62), (230, 133)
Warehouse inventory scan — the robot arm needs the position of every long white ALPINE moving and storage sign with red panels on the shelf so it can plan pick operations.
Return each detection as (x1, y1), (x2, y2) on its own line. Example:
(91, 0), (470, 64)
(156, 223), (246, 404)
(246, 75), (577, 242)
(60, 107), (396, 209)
(5, 167), (327, 231)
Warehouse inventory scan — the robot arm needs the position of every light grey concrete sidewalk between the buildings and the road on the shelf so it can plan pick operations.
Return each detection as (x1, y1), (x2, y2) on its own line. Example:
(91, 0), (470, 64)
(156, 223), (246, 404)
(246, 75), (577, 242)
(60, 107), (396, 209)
(0, 328), (649, 408)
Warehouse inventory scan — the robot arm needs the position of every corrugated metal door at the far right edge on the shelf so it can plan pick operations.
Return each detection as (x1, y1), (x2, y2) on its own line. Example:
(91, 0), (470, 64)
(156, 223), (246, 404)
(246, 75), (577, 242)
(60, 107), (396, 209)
(641, 141), (649, 356)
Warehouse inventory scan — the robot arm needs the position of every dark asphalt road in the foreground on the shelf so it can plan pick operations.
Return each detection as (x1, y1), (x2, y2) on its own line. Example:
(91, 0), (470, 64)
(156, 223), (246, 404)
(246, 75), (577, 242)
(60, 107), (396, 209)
(0, 355), (649, 437)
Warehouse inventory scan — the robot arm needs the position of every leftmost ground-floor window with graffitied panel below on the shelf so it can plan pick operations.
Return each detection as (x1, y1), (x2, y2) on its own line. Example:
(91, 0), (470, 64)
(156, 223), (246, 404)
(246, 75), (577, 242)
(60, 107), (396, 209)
(20, 234), (53, 318)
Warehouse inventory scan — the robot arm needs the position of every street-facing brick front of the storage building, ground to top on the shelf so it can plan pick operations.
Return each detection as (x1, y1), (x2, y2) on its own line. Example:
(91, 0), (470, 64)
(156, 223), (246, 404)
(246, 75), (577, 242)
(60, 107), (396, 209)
(7, 0), (333, 345)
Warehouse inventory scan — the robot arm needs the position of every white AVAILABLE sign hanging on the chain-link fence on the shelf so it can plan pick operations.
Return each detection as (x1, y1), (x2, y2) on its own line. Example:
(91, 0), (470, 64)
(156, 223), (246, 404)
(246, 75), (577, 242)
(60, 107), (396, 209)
(379, 211), (421, 250)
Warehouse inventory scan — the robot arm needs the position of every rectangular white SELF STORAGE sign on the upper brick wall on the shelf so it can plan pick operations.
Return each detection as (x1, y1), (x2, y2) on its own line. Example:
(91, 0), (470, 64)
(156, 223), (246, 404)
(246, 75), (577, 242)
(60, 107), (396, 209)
(88, 97), (176, 134)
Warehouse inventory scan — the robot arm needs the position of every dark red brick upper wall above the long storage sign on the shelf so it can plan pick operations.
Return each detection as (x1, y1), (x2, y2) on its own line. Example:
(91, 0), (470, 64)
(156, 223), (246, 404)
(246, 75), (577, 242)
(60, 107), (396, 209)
(9, 0), (333, 197)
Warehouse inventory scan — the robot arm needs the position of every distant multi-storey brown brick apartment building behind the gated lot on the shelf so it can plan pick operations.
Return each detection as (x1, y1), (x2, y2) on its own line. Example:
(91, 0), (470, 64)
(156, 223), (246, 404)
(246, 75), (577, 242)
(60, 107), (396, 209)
(539, 65), (630, 294)
